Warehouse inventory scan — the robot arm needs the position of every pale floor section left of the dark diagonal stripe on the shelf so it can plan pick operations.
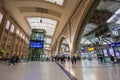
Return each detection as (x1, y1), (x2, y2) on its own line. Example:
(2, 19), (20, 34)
(0, 62), (70, 80)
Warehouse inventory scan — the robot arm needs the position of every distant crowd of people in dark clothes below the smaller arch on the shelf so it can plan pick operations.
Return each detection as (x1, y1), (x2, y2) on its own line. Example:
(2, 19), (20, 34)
(52, 56), (80, 64)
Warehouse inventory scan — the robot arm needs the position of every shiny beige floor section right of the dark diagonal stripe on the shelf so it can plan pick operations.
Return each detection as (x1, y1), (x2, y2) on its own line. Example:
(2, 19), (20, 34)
(61, 60), (120, 80)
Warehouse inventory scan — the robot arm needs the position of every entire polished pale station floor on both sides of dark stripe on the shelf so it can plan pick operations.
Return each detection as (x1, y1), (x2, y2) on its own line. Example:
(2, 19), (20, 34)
(0, 60), (120, 80)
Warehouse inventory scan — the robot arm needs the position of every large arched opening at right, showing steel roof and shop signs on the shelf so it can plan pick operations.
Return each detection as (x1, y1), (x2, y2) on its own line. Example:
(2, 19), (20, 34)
(78, 0), (120, 63)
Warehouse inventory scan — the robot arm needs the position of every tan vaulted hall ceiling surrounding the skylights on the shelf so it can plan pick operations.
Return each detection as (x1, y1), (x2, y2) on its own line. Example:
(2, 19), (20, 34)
(3, 0), (81, 49)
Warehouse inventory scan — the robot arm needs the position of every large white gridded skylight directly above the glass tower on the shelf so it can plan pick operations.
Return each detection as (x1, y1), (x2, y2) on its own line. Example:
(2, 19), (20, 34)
(27, 17), (57, 36)
